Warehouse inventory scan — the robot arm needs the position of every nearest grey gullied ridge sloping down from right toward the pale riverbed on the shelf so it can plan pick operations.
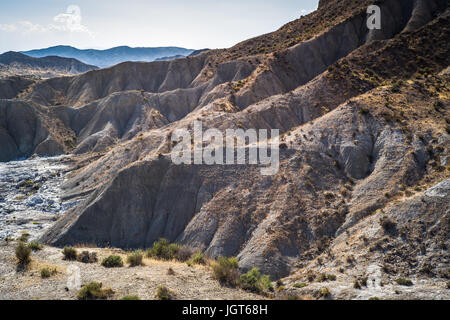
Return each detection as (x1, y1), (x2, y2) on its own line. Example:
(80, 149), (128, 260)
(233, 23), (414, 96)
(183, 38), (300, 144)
(37, 1), (449, 277)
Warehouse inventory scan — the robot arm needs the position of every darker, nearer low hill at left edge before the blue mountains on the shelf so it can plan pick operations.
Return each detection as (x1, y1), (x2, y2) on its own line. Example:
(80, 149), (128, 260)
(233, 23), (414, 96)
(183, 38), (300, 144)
(0, 51), (98, 78)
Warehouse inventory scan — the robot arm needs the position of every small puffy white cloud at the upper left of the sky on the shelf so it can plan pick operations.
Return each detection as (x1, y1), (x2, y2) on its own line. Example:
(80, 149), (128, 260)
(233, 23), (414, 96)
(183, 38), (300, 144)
(0, 5), (93, 37)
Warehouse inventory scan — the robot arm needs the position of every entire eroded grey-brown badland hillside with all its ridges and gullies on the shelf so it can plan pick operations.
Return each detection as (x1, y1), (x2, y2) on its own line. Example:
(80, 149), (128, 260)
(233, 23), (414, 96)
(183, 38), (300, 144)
(0, 0), (450, 298)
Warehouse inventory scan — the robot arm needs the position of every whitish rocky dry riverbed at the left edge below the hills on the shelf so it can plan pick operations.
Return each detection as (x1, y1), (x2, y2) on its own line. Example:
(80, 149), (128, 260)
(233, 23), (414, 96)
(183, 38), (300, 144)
(0, 156), (77, 241)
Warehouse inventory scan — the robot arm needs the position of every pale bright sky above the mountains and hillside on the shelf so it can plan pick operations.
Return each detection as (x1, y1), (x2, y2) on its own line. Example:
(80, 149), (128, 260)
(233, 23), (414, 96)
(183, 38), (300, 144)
(0, 0), (319, 53)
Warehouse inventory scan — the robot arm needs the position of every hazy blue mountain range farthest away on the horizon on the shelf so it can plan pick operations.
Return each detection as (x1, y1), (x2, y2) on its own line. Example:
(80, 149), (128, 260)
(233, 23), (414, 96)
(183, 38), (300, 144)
(21, 46), (195, 68)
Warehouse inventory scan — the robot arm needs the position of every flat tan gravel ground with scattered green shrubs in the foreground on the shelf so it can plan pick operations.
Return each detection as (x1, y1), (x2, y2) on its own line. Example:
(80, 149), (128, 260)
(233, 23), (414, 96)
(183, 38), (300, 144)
(0, 243), (263, 300)
